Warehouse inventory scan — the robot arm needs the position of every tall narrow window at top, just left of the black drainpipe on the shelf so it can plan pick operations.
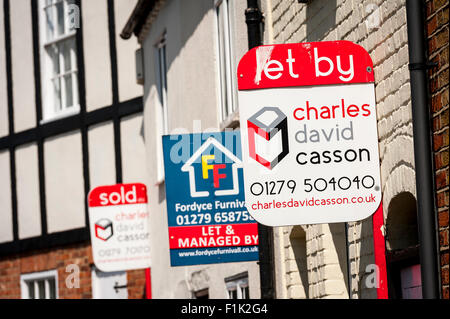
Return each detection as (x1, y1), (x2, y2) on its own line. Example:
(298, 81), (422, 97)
(216, 0), (237, 122)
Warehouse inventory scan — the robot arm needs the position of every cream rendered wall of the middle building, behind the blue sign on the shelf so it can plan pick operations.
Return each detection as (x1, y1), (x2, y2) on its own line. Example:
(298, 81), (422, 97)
(140, 0), (260, 298)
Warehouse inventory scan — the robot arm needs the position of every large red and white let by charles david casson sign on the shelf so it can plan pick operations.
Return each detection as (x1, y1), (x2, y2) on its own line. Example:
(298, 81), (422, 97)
(237, 41), (381, 226)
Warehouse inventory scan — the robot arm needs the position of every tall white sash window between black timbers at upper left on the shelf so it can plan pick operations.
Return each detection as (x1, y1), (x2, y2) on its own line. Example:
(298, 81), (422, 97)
(40, 0), (80, 122)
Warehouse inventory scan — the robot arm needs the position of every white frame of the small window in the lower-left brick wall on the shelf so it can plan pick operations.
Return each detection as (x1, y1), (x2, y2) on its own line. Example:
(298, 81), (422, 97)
(20, 270), (59, 299)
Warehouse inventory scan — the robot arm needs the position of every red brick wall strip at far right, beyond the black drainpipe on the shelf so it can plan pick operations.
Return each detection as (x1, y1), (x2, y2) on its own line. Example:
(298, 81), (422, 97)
(426, 0), (449, 299)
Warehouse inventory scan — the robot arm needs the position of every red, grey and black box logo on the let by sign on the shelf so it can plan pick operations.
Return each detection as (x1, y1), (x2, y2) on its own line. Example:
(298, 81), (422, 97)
(247, 106), (289, 170)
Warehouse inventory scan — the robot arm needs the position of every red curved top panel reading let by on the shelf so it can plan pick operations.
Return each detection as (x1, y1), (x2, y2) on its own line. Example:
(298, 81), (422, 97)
(237, 41), (374, 90)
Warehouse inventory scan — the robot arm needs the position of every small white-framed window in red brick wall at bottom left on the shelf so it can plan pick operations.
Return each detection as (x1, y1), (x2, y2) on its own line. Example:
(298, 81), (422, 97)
(20, 270), (58, 299)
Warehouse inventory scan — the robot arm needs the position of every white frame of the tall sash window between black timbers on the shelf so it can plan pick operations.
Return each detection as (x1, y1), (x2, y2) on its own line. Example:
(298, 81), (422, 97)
(38, 0), (80, 124)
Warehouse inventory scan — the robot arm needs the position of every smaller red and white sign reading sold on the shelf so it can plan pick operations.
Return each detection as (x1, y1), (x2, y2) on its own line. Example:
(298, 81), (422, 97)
(88, 183), (150, 272)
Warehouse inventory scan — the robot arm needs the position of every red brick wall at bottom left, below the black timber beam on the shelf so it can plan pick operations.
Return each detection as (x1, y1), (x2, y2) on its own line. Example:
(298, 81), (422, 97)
(0, 243), (145, 299)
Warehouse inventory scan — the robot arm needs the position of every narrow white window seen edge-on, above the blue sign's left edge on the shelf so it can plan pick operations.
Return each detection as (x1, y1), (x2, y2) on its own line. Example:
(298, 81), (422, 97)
(155, 34), (169, 182)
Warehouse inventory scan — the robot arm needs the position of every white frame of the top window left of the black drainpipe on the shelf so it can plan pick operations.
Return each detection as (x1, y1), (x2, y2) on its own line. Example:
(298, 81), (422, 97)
(214, 0), (238, 126)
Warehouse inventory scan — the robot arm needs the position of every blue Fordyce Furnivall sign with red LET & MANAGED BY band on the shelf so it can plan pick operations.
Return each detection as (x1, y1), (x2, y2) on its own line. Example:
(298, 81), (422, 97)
(163, 132), (259, 266)
